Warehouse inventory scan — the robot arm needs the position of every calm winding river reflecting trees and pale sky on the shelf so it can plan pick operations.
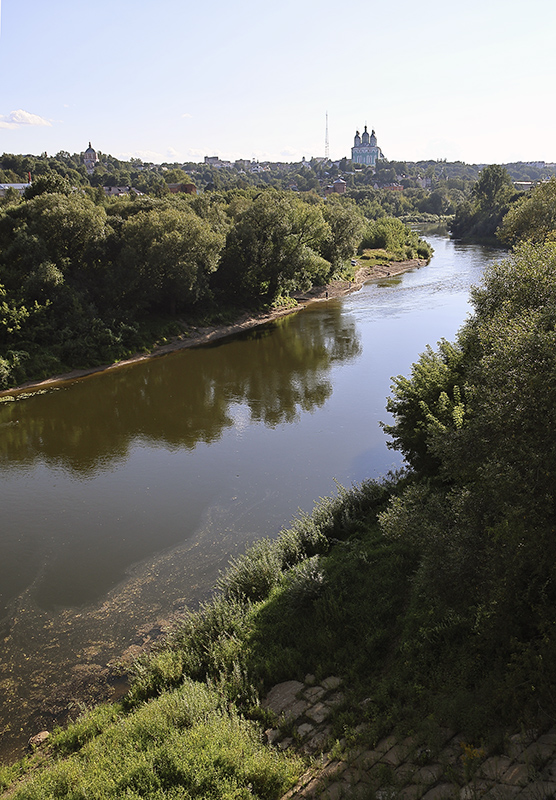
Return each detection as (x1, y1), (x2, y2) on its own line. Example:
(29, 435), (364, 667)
(0, 235), (501, 757)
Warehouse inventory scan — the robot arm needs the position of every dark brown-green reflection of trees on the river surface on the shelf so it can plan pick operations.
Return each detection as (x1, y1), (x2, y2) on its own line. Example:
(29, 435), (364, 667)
(0, 304), (361, 476)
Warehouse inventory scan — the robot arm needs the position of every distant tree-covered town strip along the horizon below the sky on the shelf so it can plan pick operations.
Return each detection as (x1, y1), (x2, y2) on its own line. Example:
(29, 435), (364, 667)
(4, 151), (554, 227)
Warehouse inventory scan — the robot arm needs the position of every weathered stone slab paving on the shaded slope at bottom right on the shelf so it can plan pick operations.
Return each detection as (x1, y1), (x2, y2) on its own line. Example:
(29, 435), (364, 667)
(263, 675), (556, 800)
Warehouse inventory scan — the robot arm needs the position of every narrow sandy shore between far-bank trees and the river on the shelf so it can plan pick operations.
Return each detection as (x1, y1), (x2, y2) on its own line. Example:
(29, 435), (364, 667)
(0, 258), (427, 397)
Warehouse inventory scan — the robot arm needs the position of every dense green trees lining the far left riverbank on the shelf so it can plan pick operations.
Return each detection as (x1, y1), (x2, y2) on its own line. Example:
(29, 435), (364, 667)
(0, 184), (431, 387)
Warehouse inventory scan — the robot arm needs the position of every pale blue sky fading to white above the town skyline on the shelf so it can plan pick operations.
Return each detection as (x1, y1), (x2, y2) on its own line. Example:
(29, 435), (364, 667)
(0, 0), (556, 164)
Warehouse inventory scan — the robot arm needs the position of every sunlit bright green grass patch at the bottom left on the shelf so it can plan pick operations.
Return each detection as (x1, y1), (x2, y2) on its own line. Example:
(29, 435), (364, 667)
(7, 680), (303, 800)
